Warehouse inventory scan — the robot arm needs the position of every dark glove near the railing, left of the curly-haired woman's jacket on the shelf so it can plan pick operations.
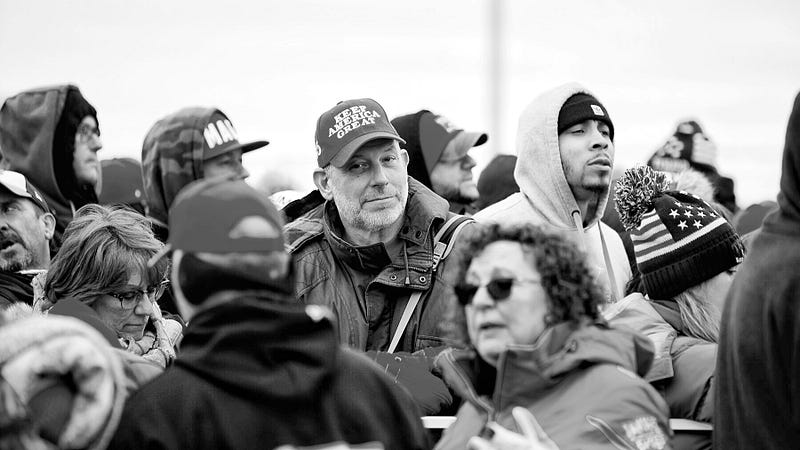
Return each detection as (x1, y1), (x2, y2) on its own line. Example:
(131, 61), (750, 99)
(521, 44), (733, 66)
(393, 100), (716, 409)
(367, 350), (453, 416)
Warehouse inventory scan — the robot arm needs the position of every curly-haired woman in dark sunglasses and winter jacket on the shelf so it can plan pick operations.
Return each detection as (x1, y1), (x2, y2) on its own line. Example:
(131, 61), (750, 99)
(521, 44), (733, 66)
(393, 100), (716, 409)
(436, 225), (671, 449)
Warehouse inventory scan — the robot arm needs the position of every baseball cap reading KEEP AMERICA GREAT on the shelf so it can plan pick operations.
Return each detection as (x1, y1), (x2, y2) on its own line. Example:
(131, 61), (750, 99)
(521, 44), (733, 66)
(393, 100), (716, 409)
(314, 98), (406, 167)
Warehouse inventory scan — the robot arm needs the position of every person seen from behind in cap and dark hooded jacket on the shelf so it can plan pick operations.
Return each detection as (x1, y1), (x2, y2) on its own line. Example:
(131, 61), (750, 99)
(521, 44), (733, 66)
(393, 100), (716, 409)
(110, 178), (428, 449)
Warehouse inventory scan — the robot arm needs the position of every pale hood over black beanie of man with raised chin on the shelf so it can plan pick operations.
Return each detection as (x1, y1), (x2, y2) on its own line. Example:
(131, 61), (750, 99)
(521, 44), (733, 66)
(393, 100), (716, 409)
(514, 83), (610, 229)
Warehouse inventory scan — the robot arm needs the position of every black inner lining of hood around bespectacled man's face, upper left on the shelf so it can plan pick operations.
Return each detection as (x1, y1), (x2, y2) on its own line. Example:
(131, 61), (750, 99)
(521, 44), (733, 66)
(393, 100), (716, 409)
(53, 86), (100, 209)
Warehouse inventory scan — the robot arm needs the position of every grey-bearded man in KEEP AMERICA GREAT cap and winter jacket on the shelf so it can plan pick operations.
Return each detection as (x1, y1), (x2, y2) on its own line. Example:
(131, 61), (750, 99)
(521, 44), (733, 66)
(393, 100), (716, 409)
(285, 98), (471, 413)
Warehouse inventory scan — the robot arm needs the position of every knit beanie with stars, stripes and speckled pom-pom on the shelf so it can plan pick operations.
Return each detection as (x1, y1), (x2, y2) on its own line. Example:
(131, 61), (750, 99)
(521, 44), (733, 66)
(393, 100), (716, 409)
(614, 166), (744, 300)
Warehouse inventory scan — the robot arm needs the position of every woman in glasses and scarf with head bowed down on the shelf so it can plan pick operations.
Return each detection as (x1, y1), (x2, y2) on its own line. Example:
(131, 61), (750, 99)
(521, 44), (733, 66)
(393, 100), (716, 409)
(39, 205), (182, 369)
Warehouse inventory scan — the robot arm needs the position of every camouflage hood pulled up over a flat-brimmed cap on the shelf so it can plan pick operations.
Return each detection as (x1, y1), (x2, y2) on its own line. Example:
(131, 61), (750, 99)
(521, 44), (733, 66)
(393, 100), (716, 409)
(142, 107), (211, 241)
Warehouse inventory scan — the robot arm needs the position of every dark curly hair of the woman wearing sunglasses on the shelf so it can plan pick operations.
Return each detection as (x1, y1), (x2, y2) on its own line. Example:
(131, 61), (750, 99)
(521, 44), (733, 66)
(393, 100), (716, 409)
(462, 224), (603, 326)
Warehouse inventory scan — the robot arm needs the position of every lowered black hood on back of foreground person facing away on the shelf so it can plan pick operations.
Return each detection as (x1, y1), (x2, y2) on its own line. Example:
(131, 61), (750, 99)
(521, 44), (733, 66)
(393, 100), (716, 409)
(175, 297), (339, 404)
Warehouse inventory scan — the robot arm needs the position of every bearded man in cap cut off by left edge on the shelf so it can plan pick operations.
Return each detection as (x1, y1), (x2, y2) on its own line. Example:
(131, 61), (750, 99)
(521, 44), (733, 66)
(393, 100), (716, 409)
(0, 170), (56, 309)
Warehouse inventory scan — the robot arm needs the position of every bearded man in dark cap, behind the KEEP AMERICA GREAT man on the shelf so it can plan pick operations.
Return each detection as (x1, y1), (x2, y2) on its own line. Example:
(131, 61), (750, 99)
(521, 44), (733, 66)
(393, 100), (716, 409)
(392, 109), (488, 214)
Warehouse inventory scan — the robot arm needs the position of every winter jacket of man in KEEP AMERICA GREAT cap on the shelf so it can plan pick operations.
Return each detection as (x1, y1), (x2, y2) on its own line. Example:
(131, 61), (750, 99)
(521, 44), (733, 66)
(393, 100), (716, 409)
(284, 178), (474, 352)
